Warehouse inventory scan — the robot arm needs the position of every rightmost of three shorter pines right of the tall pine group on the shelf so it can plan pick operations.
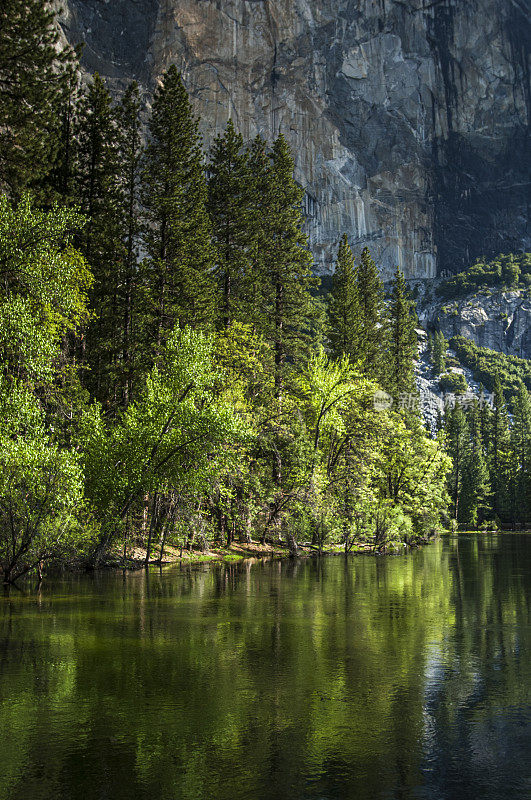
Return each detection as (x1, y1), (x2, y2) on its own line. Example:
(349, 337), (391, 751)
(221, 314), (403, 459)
(384, 267), (418, 397)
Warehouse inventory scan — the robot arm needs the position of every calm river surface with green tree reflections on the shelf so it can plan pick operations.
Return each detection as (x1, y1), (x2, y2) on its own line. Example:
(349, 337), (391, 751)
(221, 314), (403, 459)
(0, 534), (531, 800)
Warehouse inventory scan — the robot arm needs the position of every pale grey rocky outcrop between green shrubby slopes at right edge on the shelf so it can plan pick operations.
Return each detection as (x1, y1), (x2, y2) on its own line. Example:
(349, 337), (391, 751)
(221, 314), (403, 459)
(420, 292), (531, 358)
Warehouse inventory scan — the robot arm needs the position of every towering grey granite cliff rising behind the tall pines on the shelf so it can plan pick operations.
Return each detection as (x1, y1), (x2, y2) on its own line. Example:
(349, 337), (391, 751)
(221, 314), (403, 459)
(63, 0), (531, 278)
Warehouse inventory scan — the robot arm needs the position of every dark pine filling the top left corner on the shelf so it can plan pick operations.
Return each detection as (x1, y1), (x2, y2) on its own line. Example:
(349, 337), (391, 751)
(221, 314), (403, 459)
(0, 0), (76, 198)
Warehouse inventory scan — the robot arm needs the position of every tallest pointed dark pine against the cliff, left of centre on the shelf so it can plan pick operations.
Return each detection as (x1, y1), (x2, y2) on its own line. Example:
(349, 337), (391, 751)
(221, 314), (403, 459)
(142, 65), (215, 350)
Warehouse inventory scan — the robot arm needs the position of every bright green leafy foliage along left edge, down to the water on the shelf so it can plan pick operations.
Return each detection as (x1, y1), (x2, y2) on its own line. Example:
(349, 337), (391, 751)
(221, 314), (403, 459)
(0, 197), (90, 583)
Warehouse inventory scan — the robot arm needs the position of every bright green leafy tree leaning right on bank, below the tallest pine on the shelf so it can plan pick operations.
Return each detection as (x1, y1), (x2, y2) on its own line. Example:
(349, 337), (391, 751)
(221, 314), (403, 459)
(79, 328), (244, 559)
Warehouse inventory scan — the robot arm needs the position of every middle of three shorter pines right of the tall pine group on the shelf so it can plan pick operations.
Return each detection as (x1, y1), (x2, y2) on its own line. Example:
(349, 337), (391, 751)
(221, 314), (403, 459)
(356, 247), (385, 378)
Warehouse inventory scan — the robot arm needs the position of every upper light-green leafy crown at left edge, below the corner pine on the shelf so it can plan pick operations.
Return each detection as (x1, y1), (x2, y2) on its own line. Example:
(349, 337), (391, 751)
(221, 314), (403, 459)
(0, 192), (91, 386)
